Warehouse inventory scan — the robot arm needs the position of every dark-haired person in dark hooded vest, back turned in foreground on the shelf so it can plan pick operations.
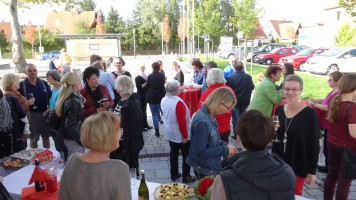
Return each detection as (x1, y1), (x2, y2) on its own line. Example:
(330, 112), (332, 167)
(211, 110), (296, 200)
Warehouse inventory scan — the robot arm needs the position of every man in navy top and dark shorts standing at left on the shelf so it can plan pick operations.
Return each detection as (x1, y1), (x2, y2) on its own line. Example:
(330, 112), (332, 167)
(18, 64), (52, 148)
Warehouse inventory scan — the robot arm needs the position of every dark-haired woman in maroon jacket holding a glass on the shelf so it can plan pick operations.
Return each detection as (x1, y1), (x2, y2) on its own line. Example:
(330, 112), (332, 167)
(80, 67), (114, 117)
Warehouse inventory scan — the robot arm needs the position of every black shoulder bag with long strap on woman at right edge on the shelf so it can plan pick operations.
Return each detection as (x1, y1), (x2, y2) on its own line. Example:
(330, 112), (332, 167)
(343, 102), (356, 179)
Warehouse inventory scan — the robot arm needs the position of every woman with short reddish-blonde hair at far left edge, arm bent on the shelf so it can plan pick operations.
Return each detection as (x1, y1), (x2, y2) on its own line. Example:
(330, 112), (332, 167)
(2, 73), (35, 115)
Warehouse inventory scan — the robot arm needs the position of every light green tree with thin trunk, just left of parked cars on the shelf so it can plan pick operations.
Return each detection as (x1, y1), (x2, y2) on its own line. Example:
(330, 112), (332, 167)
(230, 0), (263, 71)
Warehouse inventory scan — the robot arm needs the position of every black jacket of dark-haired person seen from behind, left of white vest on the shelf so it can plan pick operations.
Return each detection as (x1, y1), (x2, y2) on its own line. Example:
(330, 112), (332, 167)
(146, 71), (166, 104)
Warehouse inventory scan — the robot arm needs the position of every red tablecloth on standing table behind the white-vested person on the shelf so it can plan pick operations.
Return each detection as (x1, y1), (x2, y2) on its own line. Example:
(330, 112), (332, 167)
(178, 88), (201, 117)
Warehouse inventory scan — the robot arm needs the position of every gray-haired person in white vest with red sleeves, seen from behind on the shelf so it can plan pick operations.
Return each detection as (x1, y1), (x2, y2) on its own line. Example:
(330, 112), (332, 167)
(161, 80), (196, 183)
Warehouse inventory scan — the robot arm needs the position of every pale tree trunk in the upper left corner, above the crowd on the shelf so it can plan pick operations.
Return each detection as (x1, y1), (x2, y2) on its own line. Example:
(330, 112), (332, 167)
(9, 0), (27, 73)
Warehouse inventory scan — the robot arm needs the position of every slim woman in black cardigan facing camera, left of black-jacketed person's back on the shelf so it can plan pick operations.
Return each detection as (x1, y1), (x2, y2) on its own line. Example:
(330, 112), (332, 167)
(135, 62), (152, 130)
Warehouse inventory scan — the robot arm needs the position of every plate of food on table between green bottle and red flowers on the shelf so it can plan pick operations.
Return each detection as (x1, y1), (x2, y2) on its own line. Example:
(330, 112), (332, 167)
(154, 183), (194, 200)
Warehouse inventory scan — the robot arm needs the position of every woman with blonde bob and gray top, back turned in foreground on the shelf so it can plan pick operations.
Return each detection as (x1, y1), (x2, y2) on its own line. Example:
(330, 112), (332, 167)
(58, 111), (131, 200)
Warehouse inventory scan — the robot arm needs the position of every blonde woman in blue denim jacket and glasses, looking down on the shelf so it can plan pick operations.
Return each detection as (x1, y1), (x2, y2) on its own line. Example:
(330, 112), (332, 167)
(187, 87), (237, 179)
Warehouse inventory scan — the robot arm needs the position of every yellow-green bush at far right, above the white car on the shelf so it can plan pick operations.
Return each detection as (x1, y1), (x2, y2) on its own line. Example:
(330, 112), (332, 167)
(335, 23), (356, 47)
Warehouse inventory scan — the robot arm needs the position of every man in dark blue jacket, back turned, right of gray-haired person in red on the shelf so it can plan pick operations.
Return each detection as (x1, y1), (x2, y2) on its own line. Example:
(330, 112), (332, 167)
(226, 61), (255, 139)
